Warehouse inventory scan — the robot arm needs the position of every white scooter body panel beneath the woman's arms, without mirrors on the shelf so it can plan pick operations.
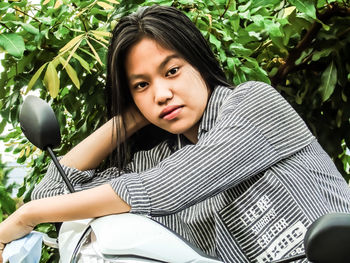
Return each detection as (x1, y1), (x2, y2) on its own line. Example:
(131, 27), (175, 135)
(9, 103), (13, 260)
(58, 213), (221, 263)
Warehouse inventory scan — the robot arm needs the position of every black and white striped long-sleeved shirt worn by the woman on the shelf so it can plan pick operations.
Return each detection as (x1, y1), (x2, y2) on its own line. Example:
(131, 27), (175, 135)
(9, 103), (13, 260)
(32, 82), (350, 262)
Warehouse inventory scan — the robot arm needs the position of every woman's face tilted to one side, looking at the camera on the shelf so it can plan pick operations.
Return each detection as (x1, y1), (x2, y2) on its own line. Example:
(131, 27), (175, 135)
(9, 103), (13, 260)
(125, 38), (210, 142)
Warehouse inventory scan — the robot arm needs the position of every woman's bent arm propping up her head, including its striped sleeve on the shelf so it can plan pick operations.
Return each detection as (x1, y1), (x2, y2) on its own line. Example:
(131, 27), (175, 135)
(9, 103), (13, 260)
(31, 106), (148, 199)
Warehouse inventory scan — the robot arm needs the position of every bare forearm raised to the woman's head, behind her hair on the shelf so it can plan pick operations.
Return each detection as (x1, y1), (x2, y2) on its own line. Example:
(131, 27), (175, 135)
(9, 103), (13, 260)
(60, 106), (148, 171)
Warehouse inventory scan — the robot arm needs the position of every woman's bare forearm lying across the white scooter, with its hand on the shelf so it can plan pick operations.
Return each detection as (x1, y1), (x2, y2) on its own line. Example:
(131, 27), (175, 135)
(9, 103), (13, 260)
(0, 184), (130, 262)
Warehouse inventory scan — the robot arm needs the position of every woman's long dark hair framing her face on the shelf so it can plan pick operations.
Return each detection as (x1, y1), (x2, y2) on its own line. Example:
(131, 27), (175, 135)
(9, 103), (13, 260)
(106, 5), (229, 169)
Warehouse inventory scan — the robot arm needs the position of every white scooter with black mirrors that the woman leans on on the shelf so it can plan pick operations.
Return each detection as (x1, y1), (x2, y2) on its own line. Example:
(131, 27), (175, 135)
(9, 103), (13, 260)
(19, 96), (350, 263)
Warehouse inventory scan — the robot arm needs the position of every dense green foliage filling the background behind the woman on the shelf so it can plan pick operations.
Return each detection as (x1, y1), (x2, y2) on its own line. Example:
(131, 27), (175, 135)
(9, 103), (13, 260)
(0, 0), (350, 262)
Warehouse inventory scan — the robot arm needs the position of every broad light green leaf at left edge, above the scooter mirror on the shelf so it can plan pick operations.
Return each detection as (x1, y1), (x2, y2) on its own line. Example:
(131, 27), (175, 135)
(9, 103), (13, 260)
(0, 33), (25, 58)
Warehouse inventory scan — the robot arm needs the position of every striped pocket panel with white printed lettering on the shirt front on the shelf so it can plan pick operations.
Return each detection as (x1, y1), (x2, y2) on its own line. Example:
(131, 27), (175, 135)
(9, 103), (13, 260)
(221, 174), (310, 263)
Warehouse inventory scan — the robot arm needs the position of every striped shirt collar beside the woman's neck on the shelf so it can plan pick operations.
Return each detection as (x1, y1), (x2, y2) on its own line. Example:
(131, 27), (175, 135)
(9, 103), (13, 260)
(198, 86), (232, 137)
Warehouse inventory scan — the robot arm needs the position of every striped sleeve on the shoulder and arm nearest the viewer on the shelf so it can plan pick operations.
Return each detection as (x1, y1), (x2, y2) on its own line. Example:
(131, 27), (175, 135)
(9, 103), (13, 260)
(110, 82), (314, 216)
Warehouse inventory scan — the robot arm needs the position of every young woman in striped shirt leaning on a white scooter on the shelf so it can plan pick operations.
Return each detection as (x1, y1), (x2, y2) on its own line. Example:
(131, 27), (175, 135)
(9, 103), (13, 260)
(0, 6), (350, 262)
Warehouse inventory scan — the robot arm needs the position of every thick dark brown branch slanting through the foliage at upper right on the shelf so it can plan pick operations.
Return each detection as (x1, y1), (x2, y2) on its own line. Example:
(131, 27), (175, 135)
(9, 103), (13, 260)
(271, 2), (350, 86)
